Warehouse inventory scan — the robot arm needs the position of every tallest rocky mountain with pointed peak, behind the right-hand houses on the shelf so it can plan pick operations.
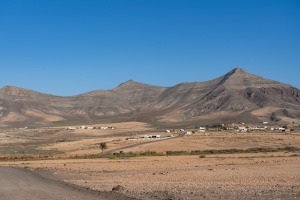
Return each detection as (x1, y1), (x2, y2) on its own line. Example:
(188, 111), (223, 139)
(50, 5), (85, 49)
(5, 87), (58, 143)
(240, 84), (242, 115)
(155, 68), (300, 122)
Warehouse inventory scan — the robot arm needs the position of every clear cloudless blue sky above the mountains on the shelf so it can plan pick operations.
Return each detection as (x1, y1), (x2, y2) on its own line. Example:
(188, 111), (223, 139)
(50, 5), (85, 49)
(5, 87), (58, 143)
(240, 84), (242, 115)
(0, 0), (300, 96)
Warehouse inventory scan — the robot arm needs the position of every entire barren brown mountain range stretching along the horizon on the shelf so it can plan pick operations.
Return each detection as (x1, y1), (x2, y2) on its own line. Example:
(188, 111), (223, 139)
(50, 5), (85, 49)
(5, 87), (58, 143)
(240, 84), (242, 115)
(0, 68), (300, 127)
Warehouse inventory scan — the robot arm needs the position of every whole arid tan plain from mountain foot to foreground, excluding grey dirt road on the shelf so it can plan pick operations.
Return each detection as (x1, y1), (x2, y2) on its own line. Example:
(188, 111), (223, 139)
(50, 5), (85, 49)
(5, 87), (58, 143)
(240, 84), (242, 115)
(0, 122), (300, 200)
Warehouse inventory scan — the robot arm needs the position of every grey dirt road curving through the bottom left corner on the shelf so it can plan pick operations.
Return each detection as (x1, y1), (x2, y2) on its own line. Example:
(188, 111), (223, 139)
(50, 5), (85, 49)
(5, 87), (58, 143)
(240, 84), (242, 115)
(0, 167), (126, 200)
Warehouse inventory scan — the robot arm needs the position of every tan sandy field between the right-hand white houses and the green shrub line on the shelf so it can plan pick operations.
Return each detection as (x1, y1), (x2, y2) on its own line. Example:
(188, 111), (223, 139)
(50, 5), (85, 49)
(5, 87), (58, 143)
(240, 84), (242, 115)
(126, 132), (300, 152)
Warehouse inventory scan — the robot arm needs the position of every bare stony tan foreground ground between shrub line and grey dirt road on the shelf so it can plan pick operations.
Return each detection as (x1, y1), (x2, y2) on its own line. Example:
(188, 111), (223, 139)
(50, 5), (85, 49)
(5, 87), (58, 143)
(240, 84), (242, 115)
(1, 153), (300, 199)
